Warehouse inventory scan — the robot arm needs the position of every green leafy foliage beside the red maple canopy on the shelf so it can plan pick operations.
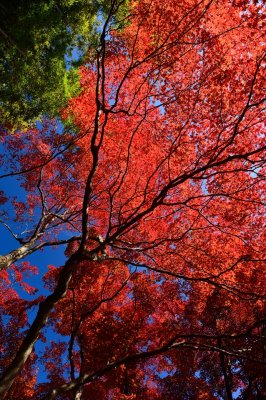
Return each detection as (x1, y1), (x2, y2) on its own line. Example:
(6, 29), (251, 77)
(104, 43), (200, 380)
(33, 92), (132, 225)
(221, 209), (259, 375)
(0, 0), (101, 130)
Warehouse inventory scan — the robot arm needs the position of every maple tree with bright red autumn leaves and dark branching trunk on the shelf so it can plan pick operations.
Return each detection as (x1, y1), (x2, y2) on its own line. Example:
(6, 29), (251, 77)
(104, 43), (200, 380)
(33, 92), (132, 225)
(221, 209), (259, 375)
(0, 0), (266, 400)
